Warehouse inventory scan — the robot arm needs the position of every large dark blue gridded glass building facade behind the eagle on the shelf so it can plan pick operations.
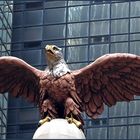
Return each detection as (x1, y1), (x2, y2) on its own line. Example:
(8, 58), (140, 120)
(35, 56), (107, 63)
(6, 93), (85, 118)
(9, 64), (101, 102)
(7, 0), (140, 139)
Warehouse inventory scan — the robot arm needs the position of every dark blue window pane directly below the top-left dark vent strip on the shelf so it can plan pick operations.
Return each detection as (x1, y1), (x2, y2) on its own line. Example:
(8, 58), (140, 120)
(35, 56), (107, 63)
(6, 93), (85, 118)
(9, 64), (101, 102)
(24, 10), (43, 25)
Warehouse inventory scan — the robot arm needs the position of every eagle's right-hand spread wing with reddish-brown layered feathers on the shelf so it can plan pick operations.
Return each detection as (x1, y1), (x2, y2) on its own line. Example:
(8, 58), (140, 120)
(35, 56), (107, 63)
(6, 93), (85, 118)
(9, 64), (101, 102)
(73, 53), (140, 119)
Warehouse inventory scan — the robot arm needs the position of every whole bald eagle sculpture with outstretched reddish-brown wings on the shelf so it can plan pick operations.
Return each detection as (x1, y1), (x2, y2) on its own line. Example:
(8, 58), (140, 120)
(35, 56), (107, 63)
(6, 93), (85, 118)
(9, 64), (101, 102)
(0, 45), (140, 128)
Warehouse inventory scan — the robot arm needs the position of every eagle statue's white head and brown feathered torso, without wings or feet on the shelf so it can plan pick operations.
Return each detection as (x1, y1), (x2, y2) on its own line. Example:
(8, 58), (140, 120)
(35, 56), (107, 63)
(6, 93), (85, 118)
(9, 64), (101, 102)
(40, 45), (81, 122)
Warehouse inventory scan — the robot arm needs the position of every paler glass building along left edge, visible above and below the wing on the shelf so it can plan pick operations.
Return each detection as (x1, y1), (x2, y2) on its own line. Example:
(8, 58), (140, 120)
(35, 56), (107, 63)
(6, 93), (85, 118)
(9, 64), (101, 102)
(0, 0), (13, 139)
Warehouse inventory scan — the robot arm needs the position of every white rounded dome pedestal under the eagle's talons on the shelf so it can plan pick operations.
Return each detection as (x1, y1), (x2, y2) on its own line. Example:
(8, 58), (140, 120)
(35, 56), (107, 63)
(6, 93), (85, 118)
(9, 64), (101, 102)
(33, 119), (85, 139)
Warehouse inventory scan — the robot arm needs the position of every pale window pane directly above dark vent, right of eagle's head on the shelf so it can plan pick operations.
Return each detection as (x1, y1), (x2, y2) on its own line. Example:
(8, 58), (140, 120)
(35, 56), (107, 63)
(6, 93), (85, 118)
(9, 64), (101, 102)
(90, 21), (109, 36)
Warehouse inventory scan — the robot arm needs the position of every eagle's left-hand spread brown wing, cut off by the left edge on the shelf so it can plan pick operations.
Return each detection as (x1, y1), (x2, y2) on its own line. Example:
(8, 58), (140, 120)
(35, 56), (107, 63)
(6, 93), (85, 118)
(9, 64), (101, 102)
(0, 56), (43, 102)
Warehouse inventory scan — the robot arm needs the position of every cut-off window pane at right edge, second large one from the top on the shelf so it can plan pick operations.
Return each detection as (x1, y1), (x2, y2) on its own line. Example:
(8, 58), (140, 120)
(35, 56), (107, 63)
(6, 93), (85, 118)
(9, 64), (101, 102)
(130, 18), (140, 32)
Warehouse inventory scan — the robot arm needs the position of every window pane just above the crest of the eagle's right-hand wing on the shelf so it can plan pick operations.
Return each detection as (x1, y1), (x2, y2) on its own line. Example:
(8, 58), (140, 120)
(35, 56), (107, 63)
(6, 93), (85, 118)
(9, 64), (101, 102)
(110, 43), (128, 53)
